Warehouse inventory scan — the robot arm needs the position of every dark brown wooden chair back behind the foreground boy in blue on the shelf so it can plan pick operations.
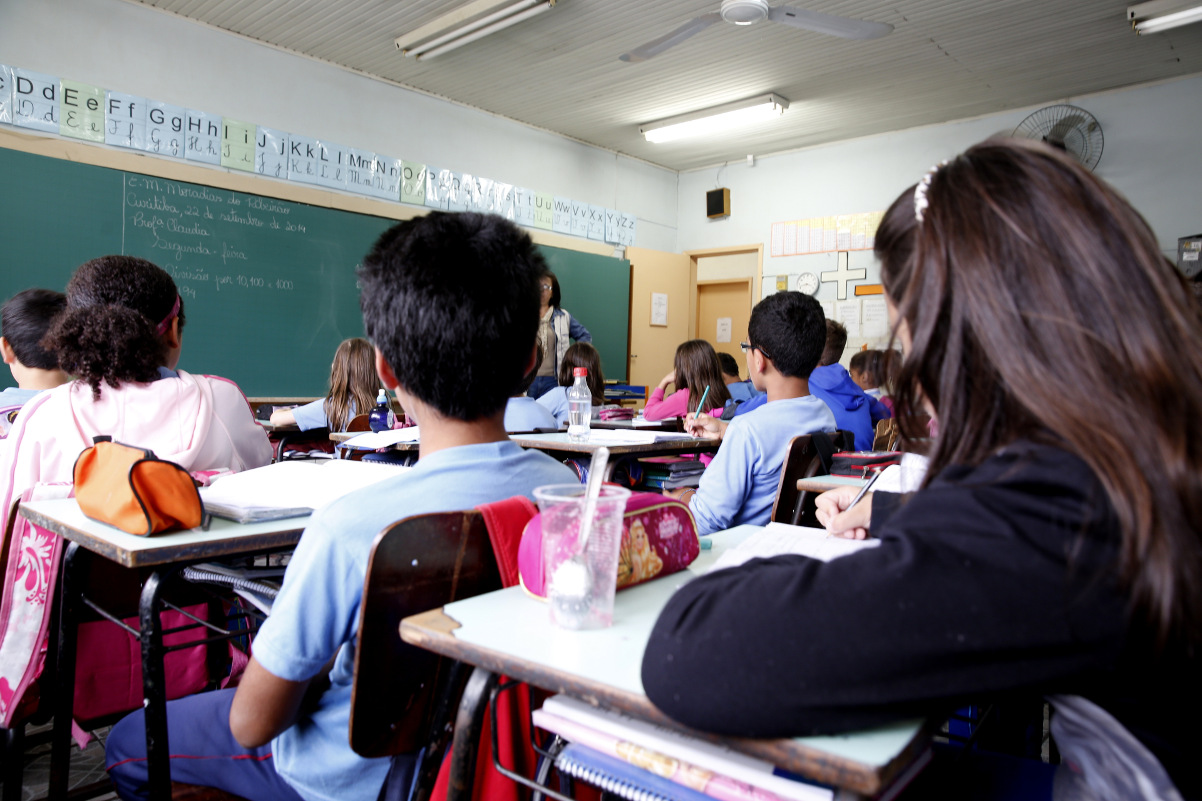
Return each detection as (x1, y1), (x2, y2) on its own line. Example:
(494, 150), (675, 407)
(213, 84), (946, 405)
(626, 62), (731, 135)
(350, 511), (501, 758)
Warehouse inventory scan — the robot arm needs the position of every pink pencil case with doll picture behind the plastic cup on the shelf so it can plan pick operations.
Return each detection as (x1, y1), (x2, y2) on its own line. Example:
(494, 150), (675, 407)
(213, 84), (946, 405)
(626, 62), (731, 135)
(518, 492), (701, 598)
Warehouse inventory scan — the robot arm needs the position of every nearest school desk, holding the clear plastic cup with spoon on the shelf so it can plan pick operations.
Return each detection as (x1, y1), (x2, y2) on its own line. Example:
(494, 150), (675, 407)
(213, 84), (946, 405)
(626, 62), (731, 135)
(400, 526), (932, 799)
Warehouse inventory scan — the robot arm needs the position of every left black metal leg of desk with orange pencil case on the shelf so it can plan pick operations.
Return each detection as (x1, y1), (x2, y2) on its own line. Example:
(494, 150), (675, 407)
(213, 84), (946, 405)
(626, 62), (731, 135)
(47, 542), (89, 799)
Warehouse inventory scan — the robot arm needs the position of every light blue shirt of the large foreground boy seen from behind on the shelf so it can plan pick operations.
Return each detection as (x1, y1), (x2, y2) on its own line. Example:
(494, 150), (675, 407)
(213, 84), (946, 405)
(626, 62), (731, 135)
(255, 441), (577, 801)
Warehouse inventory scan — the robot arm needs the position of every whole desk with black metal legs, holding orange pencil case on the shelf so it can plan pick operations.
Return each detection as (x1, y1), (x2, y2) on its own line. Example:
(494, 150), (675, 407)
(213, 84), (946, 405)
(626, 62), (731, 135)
(20, 498), (309, 799)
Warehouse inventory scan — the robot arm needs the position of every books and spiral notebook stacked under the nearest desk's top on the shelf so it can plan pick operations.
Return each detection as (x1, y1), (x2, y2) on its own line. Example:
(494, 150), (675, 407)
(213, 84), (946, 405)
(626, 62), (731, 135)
(534, 695), (834, 801)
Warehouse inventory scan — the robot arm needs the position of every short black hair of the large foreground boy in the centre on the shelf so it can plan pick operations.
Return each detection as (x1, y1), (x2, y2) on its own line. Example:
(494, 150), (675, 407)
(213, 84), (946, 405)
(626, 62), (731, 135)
(358, 212), (546, 421)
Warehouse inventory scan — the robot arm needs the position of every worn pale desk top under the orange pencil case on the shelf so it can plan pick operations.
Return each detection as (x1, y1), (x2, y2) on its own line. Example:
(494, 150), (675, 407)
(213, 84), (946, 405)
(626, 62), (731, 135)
(20, 498), (309, 568)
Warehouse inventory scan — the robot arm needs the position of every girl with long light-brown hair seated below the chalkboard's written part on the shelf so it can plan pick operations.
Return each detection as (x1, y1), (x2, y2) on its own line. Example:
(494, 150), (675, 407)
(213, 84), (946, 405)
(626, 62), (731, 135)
(272, 337), (380, 431)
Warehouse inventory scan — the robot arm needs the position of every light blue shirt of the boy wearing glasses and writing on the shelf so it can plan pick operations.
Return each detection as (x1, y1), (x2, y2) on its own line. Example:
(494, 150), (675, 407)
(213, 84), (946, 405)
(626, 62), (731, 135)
(689, 394), (835, 534)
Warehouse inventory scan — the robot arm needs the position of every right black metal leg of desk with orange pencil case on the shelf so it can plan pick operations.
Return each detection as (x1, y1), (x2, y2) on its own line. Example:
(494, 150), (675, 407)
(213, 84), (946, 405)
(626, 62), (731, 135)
(138, 570), (171, 801)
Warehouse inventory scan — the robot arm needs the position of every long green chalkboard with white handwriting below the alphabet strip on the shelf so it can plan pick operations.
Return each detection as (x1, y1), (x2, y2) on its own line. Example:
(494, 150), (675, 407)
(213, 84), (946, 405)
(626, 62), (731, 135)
(0, 149), (630, 396)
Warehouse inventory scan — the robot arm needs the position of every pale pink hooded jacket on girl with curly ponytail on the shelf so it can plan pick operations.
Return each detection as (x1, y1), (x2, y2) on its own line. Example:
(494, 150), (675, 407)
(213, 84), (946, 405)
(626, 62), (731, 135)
(0, 370), (272, 534)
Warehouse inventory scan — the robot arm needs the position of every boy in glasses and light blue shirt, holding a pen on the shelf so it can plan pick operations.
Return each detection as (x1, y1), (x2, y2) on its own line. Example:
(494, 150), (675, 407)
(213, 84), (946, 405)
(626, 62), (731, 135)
(668, 292), (835, 534)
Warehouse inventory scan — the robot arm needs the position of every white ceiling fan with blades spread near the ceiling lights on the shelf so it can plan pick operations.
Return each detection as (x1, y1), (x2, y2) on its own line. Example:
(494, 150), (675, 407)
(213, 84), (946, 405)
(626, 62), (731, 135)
(618, 0), (893, 63)
